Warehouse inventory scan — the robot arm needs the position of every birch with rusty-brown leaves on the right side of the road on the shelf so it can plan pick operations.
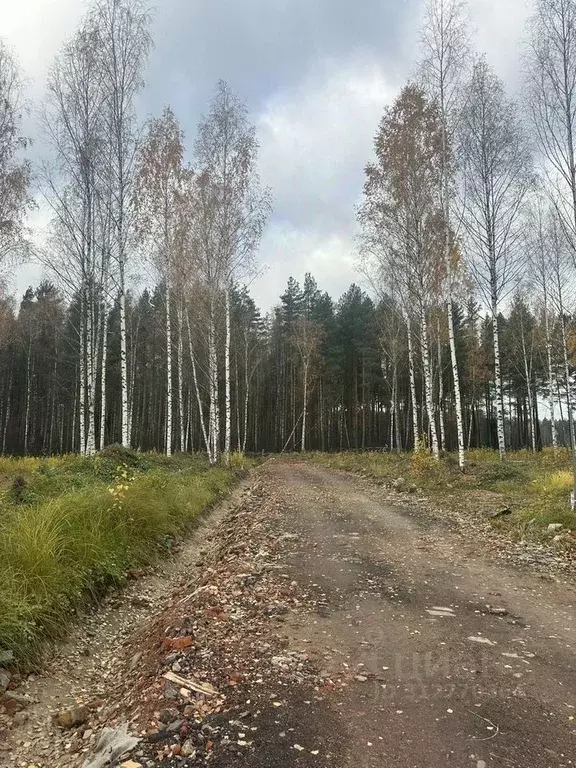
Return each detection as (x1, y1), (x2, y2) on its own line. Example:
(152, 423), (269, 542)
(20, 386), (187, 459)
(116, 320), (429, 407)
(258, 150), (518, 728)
(360, 85), (443, 459)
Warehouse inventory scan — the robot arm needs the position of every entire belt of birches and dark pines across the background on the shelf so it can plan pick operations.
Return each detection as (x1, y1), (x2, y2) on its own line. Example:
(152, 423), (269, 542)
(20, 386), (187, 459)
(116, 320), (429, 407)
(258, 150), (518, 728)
(0, 0), (576, 466)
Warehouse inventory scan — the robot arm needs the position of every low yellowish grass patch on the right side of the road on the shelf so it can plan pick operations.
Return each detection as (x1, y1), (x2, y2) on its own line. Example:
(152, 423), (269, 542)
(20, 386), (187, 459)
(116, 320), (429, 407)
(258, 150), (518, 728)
(310, 449), (576, 541)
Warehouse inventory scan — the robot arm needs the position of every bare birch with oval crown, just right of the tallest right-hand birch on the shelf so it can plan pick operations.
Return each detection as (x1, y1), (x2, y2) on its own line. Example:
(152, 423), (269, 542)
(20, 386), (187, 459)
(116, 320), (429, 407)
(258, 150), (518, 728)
(460, 59), (531, 460)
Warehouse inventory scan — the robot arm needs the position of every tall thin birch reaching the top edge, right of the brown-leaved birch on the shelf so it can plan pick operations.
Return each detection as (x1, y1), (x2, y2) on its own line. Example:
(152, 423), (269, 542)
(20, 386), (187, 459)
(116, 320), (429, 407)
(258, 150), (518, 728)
(421, 0), (469, 469)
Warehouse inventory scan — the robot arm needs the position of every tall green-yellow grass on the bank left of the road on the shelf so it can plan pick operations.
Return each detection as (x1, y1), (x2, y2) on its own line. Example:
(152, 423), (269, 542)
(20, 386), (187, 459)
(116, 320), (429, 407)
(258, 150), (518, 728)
(0, 447), (251, 668)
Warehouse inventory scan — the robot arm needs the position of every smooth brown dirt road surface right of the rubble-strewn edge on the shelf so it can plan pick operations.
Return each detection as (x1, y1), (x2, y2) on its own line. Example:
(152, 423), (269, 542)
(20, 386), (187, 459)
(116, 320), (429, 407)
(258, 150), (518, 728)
(270, 463), (576, 768)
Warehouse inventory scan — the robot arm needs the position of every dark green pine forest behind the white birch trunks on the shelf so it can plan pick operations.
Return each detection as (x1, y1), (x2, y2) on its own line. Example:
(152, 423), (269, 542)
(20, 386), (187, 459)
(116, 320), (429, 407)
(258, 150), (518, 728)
(0, 274), (576, 454)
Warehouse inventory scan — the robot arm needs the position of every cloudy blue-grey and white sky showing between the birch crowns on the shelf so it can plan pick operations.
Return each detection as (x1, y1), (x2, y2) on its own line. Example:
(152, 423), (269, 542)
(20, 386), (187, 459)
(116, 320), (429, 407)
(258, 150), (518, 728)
(0, 0), (529, 308)
